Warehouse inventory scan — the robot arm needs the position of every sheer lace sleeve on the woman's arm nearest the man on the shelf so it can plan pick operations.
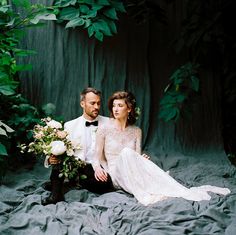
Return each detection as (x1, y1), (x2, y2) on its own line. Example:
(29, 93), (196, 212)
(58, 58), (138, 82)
(92, 126), (105, 169)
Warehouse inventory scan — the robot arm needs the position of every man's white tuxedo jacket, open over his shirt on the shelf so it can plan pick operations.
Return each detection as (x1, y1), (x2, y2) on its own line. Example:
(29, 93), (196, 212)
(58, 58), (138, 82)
(64, 115), (109, 165)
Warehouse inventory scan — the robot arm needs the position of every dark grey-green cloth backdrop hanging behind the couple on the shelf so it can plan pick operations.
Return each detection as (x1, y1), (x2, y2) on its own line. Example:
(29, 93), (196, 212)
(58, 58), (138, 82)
(20, 0), (223, 154)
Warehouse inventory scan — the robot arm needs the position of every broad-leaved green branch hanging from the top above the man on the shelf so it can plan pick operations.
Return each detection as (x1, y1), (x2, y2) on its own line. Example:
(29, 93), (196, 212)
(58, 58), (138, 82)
(54, 0), (125, 41)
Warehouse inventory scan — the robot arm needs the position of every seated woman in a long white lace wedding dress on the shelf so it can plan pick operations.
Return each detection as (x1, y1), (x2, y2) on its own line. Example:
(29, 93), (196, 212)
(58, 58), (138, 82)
(93, 91), (230, 205)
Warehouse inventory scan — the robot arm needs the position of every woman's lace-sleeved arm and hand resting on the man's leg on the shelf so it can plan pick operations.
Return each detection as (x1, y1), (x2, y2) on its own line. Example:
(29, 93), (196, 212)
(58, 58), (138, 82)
(92, 127), (107, 181)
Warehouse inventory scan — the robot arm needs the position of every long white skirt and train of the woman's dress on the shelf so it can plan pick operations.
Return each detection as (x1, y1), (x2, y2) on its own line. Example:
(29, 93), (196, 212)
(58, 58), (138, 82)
(110, 148), (230, 205)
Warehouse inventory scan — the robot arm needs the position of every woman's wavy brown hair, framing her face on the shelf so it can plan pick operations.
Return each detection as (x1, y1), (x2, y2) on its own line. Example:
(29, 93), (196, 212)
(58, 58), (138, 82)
(108, 91), (137, 125)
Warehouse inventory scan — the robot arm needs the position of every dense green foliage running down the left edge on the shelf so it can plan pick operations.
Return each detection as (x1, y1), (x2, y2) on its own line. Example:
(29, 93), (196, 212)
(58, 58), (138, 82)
(0, 0), (56, 180)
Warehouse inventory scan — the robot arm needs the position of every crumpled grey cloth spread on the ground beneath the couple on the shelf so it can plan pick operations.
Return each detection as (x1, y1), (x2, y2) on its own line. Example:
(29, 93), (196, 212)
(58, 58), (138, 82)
(0, 153), (236, 235)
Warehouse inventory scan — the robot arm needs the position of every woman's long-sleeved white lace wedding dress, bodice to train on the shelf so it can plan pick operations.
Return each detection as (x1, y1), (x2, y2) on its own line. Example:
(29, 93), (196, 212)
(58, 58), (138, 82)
(96, 120), (230, 205)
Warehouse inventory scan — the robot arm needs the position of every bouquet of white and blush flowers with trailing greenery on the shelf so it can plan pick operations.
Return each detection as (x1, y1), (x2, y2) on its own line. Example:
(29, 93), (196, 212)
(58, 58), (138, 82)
(20, 117), (86, 179)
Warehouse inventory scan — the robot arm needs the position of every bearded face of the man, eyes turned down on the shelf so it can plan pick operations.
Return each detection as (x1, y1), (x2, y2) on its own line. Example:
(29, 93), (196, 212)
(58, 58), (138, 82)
(80, 92), (101, 120)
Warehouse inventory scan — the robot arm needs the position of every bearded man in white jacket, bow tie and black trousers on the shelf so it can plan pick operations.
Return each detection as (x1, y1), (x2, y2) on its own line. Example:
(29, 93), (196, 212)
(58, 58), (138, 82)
(42, 87), (113, 205)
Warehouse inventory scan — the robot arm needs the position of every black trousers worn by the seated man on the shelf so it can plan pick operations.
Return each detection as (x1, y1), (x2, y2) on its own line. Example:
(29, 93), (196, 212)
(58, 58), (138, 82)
(50, 164), (114, 201)
